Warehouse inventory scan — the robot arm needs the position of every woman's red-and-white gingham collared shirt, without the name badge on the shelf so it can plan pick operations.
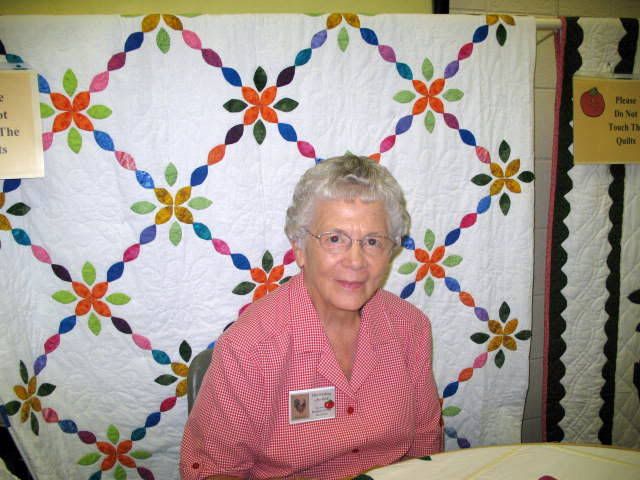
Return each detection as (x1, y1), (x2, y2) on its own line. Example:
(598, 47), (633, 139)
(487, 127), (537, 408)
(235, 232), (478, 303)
(180, 274), (442, 480)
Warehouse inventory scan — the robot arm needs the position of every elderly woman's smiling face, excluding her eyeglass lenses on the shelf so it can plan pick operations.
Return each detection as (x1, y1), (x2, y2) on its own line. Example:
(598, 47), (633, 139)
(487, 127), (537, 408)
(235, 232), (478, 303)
(293, 200), (391, 321)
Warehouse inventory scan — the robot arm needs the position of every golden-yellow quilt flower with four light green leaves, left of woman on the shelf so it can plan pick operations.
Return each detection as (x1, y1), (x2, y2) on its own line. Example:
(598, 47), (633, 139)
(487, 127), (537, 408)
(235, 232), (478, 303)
(131, 163), (213, 246)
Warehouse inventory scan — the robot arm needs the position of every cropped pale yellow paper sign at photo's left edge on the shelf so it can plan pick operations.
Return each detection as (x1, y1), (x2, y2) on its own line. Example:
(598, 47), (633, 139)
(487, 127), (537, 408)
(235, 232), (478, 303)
(0, 64), (44, 178)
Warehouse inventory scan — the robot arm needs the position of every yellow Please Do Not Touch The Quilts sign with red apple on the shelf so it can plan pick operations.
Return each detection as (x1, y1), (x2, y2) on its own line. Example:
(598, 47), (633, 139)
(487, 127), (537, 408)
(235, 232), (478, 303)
(573, 76), (640, 164)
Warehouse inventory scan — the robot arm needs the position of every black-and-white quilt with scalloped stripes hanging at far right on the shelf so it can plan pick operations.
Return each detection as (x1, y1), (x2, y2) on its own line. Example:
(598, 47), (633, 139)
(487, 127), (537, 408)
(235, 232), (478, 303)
(544, 18), (640, 448)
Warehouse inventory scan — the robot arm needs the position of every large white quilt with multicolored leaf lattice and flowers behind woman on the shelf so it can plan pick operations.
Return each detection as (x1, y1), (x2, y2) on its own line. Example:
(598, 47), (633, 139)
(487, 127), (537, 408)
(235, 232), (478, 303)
(0, 13), (535, 479)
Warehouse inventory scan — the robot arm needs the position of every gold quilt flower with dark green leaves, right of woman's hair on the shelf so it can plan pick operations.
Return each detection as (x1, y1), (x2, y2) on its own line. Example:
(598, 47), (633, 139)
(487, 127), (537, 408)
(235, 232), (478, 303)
(471, 140), (535, 215)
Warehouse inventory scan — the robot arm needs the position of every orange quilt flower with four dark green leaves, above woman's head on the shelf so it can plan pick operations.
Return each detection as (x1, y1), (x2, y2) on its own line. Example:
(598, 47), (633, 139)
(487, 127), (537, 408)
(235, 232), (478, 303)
(223, 67), (298, 144)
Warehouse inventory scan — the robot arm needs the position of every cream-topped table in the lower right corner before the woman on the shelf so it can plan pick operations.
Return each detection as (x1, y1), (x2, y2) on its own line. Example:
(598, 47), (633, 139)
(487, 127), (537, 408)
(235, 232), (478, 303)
(357, 443), (640, 480)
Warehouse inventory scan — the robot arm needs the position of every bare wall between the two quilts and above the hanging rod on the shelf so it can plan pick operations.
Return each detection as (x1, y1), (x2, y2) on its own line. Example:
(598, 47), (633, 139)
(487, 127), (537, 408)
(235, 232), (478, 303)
(450, 0), (640, 442)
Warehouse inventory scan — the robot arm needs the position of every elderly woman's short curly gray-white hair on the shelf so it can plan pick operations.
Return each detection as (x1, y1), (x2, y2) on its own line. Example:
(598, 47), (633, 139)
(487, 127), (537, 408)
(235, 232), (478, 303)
(284, 155), (411, 246)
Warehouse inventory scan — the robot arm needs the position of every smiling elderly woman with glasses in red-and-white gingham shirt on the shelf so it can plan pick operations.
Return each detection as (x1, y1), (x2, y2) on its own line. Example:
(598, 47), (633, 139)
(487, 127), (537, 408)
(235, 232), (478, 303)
(180, 156), (442, 479)
